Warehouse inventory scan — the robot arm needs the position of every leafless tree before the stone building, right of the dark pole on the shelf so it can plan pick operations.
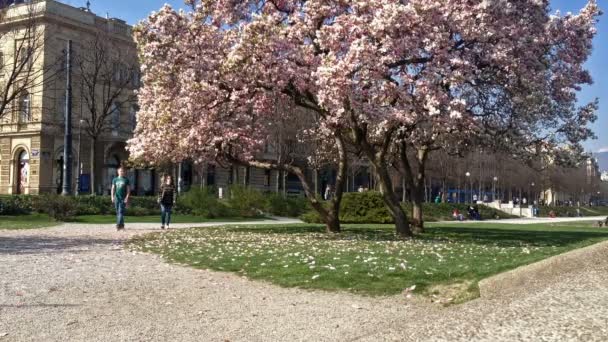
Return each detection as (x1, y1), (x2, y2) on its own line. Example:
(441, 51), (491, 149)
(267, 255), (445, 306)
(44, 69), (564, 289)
(74, 31), (139, 193)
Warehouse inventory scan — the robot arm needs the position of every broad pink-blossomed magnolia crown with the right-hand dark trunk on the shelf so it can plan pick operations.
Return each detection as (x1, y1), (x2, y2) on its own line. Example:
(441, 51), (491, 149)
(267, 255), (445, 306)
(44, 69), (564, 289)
(132, 0), (599, 236)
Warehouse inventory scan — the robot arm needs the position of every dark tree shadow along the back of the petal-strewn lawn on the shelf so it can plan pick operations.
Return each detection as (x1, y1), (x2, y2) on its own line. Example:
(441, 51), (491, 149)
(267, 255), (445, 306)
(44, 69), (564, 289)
(220, 225), (608, 247)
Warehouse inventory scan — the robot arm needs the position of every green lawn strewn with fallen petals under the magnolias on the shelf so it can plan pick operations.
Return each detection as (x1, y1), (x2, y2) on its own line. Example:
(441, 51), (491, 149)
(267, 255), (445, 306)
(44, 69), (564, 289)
(129, 223), (608, 302)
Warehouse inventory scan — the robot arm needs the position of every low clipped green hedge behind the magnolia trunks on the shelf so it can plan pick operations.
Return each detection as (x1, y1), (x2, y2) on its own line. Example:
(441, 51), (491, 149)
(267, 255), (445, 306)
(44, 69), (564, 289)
(301, 191), (512, 223)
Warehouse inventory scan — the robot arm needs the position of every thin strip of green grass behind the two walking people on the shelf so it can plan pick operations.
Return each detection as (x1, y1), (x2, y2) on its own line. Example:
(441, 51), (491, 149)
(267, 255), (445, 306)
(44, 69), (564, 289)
(70, 214), (265, 225)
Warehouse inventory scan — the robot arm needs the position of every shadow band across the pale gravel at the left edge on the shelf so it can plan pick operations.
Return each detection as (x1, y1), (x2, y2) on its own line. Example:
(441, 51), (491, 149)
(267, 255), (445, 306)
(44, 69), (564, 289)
(0, 236), (116, 255)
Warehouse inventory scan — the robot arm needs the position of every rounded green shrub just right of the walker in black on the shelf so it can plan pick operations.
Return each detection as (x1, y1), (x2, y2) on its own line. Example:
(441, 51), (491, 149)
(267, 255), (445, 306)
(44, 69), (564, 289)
(178, 187), (231, 218)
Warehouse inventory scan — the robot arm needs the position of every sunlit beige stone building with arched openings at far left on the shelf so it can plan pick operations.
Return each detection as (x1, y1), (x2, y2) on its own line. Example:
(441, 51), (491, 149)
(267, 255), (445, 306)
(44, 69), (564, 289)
(0, 0), (140, 194)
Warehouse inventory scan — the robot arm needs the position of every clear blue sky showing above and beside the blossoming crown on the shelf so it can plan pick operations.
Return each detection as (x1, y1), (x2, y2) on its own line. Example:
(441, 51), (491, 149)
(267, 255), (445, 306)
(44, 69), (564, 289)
(62, 0), (608, 152)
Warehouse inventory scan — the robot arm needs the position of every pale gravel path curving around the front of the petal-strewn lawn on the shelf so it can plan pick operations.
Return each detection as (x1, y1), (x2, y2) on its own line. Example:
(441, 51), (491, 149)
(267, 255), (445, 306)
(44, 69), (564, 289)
(0, 221), (608, 342)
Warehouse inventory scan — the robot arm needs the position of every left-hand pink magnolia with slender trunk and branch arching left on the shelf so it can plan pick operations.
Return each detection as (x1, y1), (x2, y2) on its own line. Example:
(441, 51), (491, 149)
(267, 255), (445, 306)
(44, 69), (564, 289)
(129, 7), (347, 232)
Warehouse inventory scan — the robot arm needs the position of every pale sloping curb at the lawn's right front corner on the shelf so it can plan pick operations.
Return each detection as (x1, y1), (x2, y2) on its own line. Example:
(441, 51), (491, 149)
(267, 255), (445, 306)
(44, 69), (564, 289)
(479, 241), (608, 298)
